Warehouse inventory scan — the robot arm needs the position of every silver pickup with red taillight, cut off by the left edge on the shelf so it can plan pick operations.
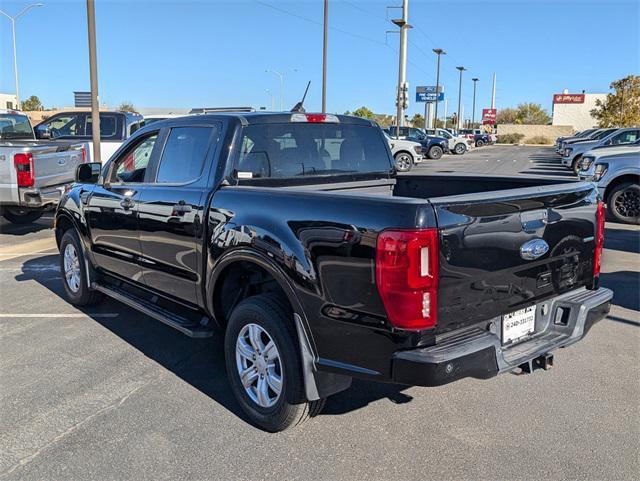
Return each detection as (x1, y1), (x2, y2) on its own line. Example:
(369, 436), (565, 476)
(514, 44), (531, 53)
(0, 110), (88, 224)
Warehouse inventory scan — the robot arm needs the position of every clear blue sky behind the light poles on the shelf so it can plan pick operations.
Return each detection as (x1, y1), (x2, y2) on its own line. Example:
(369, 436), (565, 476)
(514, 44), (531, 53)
(0, 0), (640, 116)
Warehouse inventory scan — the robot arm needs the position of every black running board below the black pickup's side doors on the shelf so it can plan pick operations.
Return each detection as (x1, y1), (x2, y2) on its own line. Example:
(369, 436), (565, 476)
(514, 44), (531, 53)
(91, 282), (214, 338)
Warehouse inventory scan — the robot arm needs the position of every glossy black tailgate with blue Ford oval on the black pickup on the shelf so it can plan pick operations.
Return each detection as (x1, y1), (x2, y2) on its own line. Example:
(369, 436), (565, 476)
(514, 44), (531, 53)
(430, 182), (597, 332)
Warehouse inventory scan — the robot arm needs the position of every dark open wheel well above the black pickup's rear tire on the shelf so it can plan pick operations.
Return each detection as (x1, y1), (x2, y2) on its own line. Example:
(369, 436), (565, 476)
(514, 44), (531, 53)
(213, 261), (293, 327)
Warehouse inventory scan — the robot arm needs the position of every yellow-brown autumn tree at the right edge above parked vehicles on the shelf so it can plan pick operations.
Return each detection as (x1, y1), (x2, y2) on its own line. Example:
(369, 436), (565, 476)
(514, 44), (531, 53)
(591, 75), (640, 127)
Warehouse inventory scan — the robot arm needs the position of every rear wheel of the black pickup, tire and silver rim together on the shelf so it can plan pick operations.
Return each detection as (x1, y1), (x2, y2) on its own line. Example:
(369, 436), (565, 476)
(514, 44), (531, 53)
(224, 293), (325, 432)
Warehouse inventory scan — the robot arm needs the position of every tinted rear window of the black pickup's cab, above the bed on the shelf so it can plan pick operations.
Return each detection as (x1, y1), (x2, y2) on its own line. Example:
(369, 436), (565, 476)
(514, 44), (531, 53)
(236, 123), (392, 179)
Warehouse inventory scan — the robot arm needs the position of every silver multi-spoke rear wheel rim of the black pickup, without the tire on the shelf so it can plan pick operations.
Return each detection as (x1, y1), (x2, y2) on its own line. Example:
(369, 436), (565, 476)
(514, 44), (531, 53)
(236, 324), (283, 408)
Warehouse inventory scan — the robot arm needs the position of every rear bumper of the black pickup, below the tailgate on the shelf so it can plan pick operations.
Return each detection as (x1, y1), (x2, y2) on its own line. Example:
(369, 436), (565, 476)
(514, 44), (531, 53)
(392, 288), (613, 386)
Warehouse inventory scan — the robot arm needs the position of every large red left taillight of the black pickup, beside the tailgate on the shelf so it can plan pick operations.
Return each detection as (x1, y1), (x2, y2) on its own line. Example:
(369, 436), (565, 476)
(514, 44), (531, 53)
(376, 229), (438, 329)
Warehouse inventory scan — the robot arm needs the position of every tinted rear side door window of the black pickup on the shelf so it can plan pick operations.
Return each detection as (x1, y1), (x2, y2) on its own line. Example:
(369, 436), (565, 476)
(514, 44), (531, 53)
(156, 127), (216, 184)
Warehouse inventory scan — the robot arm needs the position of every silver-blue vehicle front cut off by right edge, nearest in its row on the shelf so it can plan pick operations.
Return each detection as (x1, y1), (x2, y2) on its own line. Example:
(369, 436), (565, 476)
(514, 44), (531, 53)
(578, 140), (640, 225)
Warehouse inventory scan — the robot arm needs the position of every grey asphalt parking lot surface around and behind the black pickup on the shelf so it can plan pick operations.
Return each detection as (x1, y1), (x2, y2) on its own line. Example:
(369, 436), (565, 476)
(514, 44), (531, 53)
(0, 146), (640, 480)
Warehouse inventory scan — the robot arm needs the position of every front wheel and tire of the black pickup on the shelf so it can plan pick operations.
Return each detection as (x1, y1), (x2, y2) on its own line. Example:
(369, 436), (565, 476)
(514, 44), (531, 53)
(60, 229), (102, 306)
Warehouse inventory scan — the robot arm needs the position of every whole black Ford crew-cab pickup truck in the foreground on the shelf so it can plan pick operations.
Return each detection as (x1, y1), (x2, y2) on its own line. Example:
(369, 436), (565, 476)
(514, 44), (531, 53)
(55, 112), (612, 431)
